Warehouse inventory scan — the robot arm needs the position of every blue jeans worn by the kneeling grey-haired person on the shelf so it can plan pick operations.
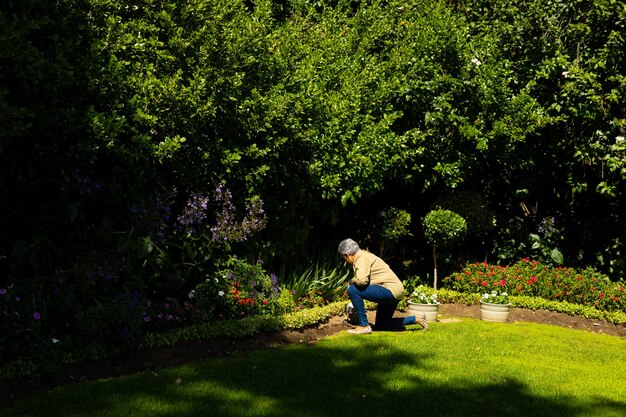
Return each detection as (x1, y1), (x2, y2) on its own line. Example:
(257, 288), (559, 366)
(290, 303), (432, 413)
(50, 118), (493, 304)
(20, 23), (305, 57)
(348, 284), (416, 330)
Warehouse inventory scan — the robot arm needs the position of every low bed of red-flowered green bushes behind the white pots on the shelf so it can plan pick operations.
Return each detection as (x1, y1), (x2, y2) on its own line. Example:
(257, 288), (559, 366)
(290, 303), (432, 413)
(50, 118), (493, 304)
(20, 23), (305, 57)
(443, 258), (626, 311)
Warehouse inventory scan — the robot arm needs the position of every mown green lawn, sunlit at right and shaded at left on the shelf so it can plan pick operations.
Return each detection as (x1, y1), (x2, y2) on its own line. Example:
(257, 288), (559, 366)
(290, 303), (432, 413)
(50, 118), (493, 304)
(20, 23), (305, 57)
(0, 319), (626, 417)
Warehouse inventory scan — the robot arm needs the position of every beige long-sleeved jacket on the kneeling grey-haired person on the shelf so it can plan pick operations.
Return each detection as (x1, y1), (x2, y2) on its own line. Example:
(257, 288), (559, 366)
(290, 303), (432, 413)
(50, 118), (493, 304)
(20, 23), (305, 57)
(350, 249), (404, 300)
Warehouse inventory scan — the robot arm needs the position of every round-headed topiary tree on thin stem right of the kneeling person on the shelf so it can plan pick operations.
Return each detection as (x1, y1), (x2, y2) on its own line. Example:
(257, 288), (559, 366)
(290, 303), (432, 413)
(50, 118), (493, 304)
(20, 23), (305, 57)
(424, 209), (467, 290)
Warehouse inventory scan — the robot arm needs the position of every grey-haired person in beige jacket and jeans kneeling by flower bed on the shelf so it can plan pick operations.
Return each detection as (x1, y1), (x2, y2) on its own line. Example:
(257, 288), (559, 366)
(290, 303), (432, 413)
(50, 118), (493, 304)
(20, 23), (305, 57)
(338, 239), (428, 334)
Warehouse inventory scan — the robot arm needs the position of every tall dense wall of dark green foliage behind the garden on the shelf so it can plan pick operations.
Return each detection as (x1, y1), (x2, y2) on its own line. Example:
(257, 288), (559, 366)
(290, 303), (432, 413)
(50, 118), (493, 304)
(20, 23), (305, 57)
(0, 0), (626, 376)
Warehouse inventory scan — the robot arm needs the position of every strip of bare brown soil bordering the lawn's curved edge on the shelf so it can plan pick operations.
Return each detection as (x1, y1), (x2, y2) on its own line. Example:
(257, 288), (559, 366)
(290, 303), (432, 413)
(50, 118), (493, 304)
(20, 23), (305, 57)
(0, 304), (626, 404)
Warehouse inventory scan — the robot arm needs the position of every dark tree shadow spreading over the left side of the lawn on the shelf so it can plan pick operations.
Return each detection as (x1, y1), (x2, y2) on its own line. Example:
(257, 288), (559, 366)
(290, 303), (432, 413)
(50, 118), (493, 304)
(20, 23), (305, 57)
(3, 337), (626, 417)
